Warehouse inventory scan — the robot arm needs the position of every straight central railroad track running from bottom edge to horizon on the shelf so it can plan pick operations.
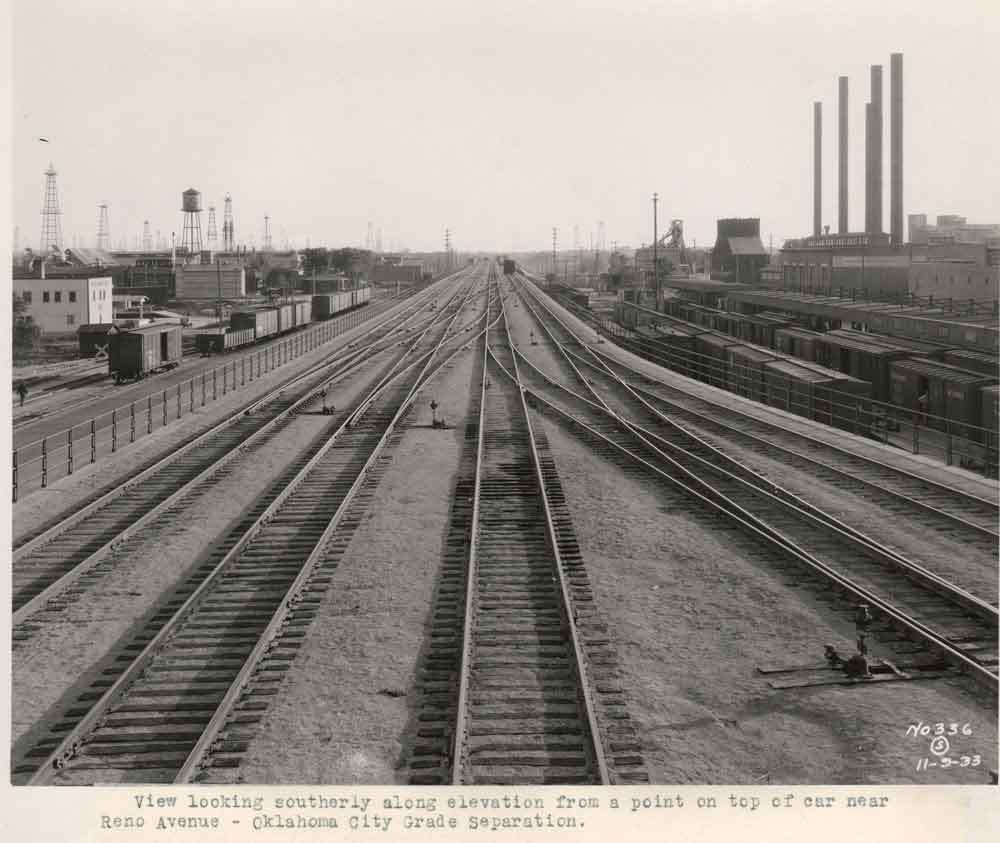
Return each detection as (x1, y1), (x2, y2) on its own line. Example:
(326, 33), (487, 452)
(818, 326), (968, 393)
(430, 280), (645, 784)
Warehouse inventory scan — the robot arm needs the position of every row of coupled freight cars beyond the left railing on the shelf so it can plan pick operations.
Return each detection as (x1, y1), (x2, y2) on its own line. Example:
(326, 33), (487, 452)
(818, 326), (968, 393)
(197, 287), (371, 356)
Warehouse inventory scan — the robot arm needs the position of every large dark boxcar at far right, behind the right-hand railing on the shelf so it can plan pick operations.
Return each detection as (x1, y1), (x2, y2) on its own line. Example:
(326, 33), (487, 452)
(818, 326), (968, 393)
(890, 358), (997, 438)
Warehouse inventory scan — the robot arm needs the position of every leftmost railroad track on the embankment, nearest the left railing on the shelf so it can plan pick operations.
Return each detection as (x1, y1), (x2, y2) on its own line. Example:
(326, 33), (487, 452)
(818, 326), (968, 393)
(12, 274), (476, 642)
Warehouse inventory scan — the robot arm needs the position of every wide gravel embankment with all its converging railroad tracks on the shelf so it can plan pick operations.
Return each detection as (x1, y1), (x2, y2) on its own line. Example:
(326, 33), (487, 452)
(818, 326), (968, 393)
(11, 257), (998, 785)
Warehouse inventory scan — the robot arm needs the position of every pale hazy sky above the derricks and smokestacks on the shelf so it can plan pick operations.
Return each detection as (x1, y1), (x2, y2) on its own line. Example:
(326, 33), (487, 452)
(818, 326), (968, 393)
(12, 0), (1000, 250)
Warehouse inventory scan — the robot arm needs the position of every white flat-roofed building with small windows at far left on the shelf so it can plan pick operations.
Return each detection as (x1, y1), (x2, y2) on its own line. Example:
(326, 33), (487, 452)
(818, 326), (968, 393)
(11, 273), (112, 334)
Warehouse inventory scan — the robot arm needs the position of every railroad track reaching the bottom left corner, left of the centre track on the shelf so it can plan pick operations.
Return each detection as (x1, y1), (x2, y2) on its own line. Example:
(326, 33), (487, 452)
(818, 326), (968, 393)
(14, 264), (492, 784)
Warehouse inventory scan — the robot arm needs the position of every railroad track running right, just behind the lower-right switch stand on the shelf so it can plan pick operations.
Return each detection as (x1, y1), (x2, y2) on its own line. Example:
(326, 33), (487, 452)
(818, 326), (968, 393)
(508, 340), (997, 694)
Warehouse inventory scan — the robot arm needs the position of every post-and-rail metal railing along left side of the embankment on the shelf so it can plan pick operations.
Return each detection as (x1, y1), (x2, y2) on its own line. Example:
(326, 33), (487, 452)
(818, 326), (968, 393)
(12, 300), (391, 503)
